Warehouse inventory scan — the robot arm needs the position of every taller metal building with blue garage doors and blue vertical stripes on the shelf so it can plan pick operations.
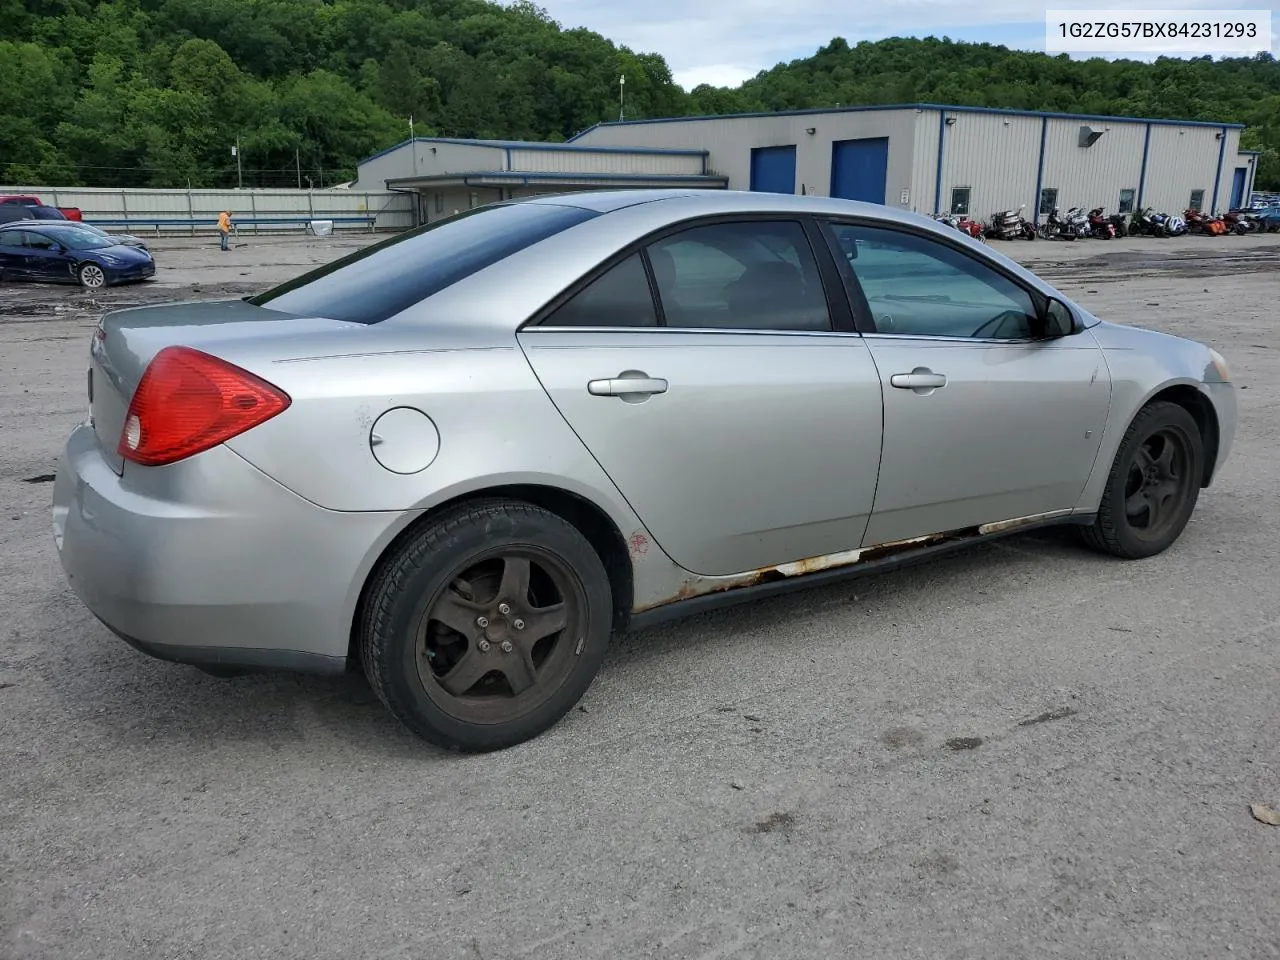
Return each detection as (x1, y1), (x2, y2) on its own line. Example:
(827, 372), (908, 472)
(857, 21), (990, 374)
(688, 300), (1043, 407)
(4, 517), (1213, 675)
(571, 104), (1257, 219)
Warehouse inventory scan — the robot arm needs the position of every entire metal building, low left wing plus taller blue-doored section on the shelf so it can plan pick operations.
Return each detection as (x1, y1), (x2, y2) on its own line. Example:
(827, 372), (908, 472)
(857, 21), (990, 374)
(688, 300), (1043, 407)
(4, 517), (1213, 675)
(356, 104), (1257, 220)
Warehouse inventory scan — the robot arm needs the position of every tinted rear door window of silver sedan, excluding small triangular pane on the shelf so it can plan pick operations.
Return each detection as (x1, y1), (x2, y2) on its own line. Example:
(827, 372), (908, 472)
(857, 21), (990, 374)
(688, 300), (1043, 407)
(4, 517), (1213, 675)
(646, 220), (831, 330)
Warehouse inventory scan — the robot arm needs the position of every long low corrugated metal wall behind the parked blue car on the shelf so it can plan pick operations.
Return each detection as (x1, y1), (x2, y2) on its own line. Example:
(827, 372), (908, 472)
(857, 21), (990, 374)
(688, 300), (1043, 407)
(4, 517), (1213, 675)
(0, 187), (413, 232)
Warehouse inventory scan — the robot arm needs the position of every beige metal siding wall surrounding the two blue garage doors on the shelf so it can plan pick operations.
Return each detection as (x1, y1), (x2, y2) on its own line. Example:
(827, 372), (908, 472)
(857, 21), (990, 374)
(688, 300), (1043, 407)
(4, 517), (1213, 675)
(575, 109), (922, 207)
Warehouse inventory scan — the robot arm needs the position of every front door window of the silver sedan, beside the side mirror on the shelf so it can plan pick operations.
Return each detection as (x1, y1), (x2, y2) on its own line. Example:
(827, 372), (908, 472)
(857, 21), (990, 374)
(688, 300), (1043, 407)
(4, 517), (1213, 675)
(828, 224), (1041, 340)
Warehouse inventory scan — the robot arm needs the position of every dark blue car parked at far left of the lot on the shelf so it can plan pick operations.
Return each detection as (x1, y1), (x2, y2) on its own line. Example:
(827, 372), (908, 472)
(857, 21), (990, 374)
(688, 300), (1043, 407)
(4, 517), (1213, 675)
(0, 220), (156, 291)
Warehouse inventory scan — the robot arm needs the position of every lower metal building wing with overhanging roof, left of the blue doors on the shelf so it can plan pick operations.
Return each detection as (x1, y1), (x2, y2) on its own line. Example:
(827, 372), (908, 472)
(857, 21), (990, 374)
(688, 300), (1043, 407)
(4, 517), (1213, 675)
(353, 137), (727, 223)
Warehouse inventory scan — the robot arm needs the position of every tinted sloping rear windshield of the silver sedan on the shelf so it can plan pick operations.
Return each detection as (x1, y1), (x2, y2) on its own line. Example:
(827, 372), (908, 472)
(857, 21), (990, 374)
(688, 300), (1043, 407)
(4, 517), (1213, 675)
(248, 202), (598, 324)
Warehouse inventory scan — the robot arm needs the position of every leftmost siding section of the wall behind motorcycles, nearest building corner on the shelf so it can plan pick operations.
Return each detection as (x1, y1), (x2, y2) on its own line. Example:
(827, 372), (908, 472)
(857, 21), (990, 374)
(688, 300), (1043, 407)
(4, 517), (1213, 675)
(929, 113), (1042, 220)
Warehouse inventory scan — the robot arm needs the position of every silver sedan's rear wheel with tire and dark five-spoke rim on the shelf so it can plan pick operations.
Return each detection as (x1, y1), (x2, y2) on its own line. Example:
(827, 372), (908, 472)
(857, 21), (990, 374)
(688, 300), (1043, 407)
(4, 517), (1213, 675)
(358, 499), (613, 753)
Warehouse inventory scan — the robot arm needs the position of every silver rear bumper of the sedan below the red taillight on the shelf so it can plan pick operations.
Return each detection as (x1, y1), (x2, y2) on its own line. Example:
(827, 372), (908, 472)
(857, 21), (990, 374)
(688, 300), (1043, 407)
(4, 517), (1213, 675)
(52, 424), (401, 673)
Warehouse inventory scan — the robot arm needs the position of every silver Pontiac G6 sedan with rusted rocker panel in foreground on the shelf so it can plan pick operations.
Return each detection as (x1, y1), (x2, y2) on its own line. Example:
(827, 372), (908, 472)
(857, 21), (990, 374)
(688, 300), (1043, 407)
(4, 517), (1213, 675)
(54, 191), (1236, 750)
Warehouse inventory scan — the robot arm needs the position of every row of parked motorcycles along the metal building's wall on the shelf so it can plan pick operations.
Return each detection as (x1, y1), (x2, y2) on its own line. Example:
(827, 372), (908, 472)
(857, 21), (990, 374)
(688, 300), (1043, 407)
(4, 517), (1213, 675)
(933, 204), (1277, 241)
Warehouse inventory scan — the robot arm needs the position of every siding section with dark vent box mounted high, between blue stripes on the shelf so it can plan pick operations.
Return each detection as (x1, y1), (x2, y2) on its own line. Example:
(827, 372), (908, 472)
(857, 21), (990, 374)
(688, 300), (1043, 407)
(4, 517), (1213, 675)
(1044, 119), (1160, 214)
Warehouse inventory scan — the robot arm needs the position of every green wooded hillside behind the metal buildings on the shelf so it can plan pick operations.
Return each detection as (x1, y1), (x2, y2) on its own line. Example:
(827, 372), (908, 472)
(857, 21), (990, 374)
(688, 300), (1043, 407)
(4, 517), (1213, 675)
(0, 0), (1280, 187)
